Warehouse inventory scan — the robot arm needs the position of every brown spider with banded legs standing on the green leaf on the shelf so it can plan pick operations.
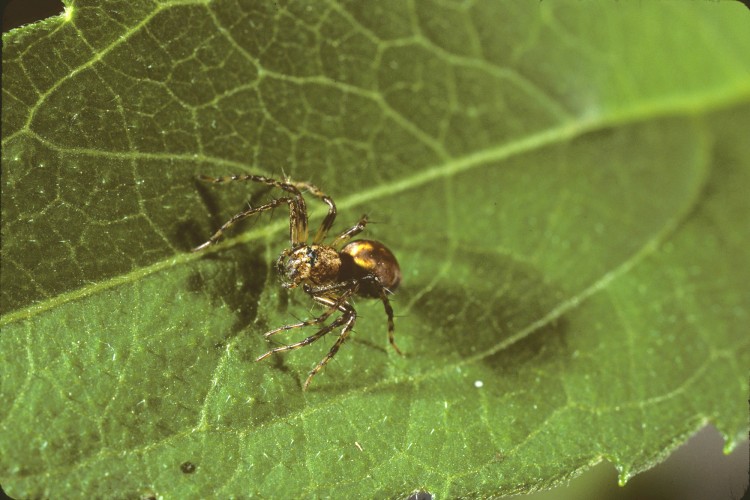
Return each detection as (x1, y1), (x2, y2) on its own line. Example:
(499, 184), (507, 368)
(193, 174), (401, 390)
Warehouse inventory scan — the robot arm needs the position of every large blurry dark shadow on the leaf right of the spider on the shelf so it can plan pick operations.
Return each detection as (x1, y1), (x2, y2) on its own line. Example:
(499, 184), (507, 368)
(406, 249), (568, 380)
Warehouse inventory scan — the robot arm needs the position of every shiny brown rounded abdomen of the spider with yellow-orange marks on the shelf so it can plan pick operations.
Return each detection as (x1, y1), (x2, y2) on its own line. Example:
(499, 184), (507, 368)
(339, 240), (401, 297)
